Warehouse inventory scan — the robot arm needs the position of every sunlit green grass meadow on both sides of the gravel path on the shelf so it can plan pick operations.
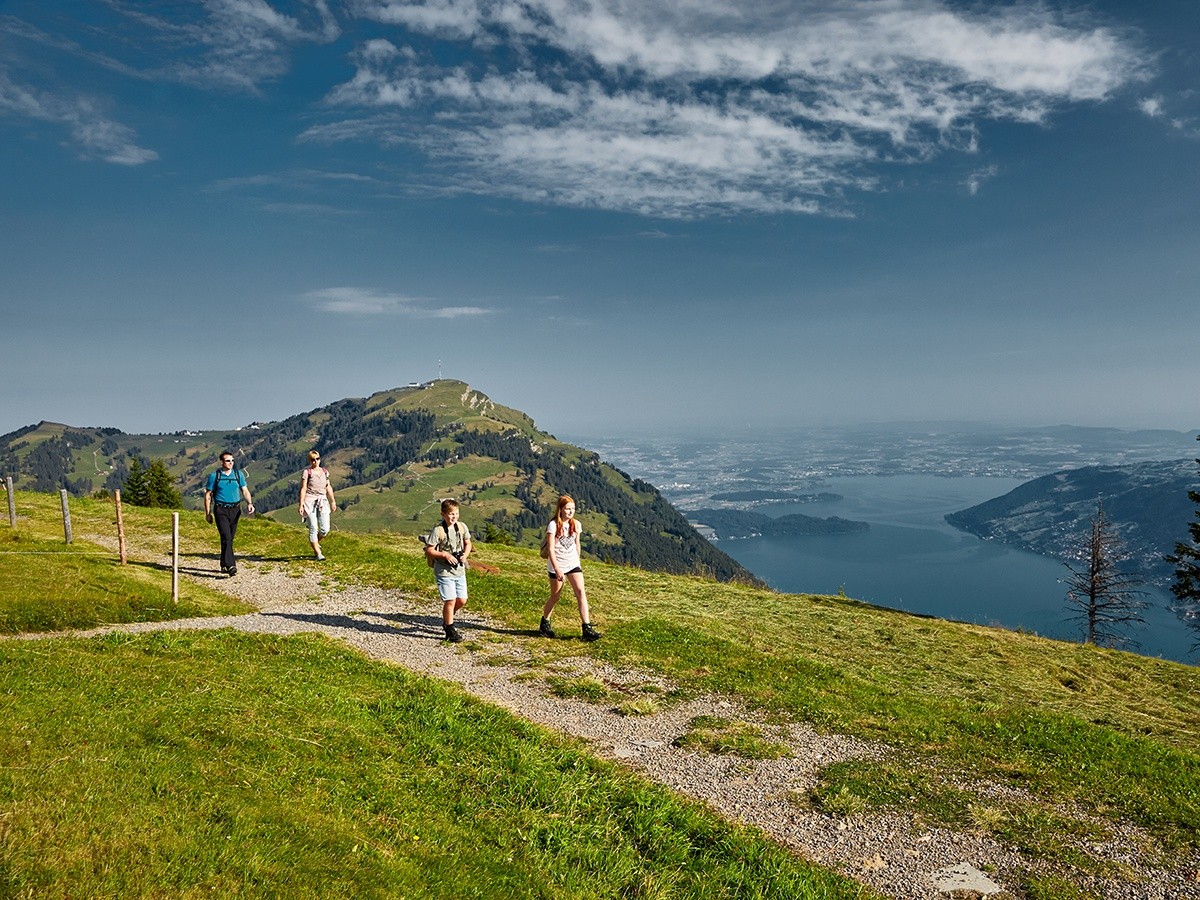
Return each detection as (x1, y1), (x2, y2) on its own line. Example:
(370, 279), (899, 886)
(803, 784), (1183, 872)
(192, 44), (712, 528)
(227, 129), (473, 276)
(0, 493), (1200, 898)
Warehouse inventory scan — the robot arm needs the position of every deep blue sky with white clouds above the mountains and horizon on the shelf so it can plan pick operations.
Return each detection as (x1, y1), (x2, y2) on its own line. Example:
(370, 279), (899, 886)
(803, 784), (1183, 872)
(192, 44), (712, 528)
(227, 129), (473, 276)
(0, 0), (1200, 438)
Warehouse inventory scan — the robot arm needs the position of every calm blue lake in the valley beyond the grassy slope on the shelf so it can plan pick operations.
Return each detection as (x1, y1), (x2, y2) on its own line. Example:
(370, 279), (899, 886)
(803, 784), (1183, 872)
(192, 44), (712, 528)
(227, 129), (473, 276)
(716, 475), (1198, 664)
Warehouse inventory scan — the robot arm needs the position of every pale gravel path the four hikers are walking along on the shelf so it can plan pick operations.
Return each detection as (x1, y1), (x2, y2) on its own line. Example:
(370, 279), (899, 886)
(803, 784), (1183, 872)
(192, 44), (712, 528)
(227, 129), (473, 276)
(11, 562), (1200, 900)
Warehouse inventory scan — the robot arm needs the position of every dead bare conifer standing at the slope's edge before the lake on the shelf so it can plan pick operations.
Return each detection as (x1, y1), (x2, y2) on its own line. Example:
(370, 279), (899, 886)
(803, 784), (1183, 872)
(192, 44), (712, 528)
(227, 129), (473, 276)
(1064, 502), (1146, 647)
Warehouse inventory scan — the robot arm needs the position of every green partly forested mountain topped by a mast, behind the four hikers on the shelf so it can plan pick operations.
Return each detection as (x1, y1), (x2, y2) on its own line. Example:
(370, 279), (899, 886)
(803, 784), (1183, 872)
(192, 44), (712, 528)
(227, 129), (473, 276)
(0, 380), (760, 583)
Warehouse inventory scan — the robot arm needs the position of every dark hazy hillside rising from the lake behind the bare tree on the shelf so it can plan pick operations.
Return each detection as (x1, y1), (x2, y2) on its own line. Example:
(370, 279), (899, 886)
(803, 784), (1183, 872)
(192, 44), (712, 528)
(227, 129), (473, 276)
(946, 460), (1200, 586)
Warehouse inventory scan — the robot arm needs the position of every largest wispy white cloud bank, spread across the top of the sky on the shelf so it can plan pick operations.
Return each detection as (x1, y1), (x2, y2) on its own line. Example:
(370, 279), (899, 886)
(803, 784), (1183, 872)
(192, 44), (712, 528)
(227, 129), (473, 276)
(314, 0), (1147, 216)
